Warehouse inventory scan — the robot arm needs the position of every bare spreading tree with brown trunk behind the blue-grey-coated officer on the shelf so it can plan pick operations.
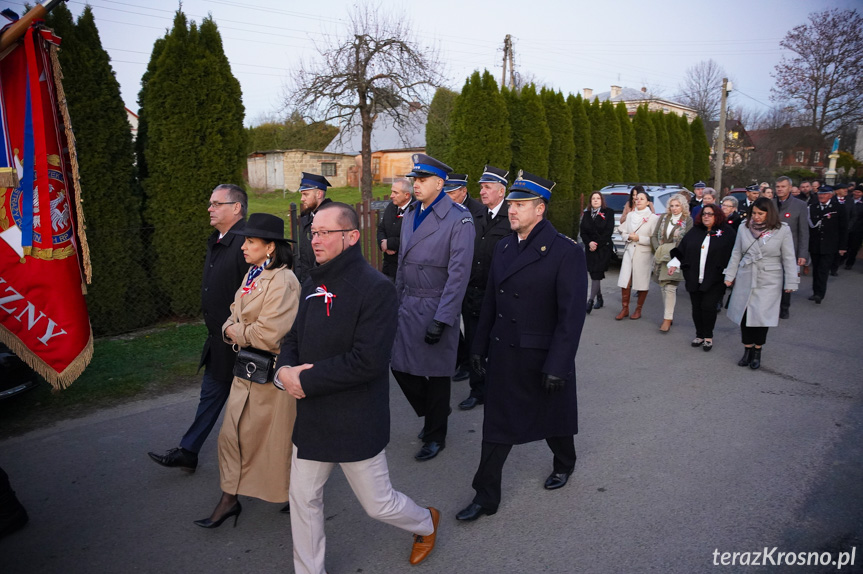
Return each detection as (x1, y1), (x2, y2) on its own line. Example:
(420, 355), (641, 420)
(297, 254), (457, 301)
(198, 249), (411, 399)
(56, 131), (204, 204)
(286, 3), (444, 199)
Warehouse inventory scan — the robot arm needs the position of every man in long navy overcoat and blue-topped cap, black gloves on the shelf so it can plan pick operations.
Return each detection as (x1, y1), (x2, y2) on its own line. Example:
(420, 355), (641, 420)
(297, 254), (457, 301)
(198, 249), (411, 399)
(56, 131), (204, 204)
(456, 172), (587, 520)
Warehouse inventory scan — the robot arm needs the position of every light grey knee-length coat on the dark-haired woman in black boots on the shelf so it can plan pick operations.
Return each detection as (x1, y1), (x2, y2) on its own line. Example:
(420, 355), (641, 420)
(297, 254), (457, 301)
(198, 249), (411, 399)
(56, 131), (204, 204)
(725, 222), (800, 327)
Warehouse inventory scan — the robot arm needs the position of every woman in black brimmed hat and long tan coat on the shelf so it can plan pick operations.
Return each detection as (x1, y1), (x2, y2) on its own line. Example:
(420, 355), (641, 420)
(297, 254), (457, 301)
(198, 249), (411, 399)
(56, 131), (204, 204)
(195, 213), (300, 528)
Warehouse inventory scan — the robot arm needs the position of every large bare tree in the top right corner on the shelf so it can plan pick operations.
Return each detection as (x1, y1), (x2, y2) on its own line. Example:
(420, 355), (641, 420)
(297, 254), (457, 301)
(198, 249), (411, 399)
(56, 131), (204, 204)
(771, 9), (863, 136)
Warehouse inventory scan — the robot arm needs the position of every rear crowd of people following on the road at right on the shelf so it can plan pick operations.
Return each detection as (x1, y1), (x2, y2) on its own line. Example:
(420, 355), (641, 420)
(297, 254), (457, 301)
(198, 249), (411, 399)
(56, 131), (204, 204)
(580, 176), (863, 369)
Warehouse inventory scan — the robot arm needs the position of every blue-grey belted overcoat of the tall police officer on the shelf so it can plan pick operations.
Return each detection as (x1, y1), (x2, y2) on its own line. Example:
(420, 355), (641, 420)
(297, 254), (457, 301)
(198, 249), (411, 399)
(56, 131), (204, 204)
(391, 195), (476, 377)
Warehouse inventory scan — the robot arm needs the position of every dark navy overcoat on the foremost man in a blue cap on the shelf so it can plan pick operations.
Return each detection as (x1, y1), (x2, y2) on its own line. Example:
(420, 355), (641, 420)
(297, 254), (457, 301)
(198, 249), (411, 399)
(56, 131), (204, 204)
(473, 220), (587, 444)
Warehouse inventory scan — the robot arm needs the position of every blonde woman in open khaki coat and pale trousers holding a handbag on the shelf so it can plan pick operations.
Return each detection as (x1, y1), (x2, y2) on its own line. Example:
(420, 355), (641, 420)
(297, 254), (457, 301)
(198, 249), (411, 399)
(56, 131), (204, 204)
(650, 194), (692, 333)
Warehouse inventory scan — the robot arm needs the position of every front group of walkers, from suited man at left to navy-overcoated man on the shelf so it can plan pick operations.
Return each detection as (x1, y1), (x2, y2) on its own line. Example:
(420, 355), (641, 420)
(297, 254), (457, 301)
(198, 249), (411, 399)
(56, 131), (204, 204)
(149, 154), (592, 574)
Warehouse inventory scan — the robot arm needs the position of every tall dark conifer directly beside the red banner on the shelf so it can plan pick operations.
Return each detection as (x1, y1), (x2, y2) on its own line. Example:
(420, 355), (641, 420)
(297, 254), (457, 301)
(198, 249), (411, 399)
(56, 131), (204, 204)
(47, 3), (156, 335)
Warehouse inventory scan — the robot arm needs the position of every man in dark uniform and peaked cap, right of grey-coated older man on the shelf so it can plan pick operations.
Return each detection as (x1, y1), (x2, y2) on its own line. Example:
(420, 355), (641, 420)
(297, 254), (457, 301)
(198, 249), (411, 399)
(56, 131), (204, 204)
(809, 185), (848, 304)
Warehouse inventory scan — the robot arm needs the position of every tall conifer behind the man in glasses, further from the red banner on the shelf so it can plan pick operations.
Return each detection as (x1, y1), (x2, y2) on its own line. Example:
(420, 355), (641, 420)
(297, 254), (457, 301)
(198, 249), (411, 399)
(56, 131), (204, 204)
(139, 11), (246, 315)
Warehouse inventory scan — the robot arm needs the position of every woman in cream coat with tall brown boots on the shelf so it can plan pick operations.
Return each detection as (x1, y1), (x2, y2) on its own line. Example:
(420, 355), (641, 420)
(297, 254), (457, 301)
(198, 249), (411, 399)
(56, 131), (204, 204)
(615, 190), (659, 321)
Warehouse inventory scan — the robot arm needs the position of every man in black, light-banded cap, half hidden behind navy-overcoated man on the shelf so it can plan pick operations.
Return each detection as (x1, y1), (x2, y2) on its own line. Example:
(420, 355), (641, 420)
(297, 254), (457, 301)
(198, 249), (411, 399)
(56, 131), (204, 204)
(458, 165), (512, 410)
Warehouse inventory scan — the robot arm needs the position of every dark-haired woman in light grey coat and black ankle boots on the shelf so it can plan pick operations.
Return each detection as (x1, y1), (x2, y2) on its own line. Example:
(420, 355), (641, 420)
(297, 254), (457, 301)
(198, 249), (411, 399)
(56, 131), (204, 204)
(725, 197), (800, 369)
